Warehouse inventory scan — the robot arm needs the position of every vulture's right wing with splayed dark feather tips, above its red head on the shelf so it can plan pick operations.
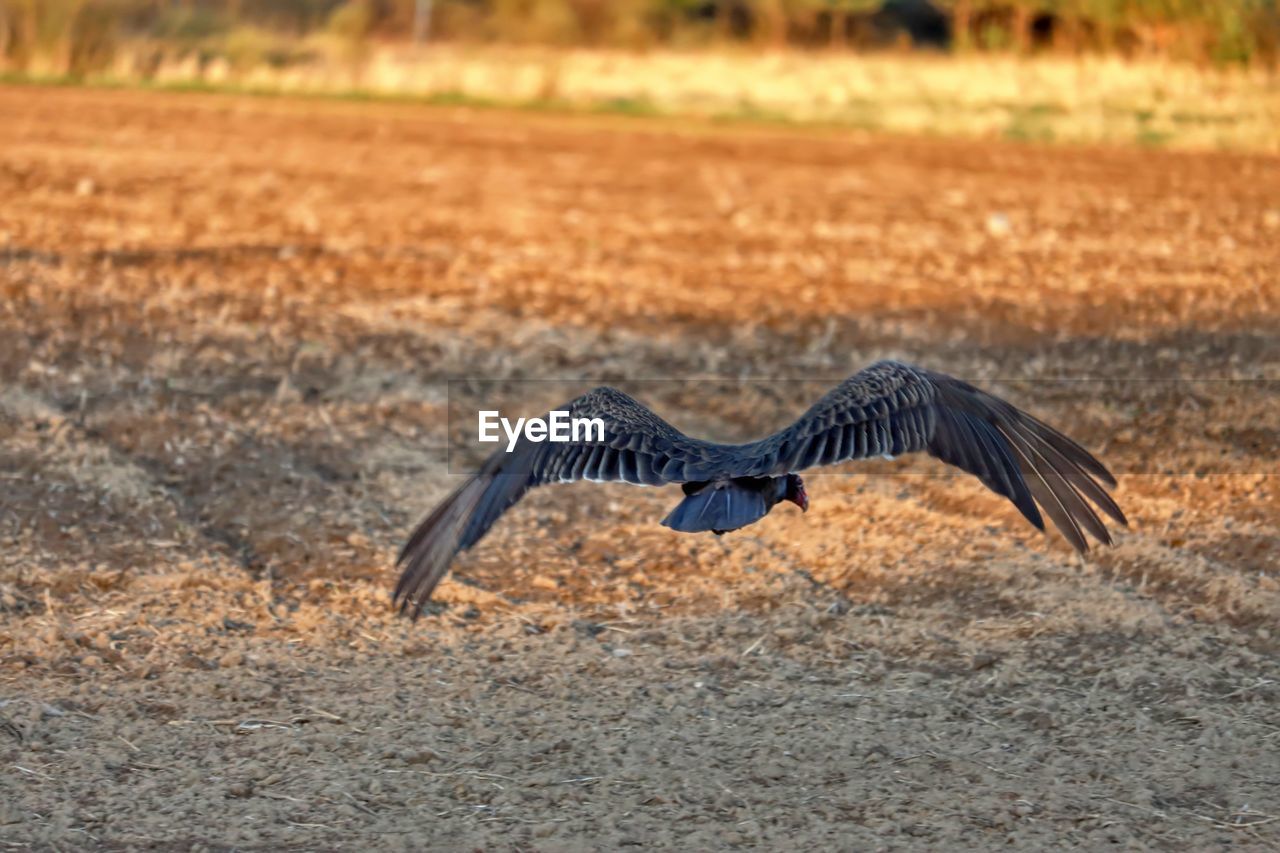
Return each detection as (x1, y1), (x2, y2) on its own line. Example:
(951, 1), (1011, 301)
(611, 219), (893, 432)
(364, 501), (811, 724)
(733, 361), (1128, 552)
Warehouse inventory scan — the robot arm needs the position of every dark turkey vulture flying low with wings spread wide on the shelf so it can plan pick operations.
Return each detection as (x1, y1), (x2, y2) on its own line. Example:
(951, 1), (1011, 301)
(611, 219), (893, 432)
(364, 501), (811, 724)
(394, 361), (1128, 617)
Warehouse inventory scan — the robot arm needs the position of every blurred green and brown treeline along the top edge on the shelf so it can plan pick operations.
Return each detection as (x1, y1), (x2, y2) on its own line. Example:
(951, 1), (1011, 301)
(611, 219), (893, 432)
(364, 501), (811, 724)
(0, 0), (1280, 74)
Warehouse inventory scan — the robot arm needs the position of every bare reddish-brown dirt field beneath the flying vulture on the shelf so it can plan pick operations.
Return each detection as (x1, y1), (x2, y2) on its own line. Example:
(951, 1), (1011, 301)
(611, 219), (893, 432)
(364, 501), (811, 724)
(0, 88), (1280, 850)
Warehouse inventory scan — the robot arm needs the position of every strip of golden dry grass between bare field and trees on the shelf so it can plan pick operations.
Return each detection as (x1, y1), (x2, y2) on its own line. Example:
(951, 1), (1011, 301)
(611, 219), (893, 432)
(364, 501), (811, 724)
(12, 41), (1280, 151)
